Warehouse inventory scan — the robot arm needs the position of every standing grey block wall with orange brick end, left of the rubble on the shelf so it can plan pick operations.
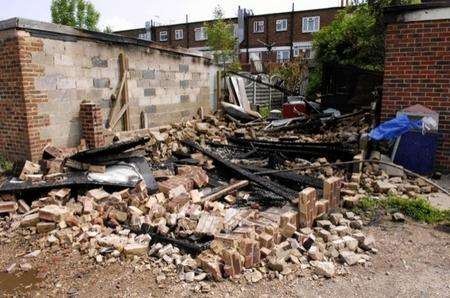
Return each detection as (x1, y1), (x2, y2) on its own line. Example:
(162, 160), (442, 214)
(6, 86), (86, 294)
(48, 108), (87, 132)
(0, 19), (216, 160)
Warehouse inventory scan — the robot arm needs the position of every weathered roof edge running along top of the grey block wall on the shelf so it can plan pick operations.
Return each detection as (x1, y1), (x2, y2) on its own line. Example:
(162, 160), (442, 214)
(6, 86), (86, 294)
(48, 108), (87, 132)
(0, 18), (211, 60)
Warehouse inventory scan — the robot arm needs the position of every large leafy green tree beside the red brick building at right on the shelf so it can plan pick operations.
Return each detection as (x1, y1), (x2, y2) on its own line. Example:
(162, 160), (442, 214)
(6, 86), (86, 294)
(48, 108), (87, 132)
(308, 0), (417, 94)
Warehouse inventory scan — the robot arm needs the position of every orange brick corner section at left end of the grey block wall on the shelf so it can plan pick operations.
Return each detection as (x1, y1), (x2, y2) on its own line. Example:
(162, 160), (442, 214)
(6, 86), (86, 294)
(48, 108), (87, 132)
(0, 30), (47, 160)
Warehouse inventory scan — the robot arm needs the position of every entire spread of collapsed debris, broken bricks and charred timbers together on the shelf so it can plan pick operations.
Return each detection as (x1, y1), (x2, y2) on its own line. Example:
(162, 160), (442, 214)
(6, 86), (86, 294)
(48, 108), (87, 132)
(0, 111), (442, 291)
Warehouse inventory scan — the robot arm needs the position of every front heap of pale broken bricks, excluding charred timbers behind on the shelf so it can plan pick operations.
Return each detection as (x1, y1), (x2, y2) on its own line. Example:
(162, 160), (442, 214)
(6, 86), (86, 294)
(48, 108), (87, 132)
(0, 166), (376, 282)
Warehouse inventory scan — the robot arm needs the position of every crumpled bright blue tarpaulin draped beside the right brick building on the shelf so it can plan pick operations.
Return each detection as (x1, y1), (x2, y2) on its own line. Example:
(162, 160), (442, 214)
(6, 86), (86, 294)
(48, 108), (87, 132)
(369, 115), (422, 141)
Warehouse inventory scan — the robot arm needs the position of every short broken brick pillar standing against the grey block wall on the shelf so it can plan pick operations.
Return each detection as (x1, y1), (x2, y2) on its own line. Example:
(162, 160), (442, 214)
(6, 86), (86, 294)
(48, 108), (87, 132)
(80, 102), (105, 148)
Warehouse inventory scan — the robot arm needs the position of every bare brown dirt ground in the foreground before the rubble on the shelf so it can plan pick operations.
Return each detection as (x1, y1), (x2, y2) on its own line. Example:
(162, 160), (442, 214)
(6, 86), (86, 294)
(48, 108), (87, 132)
(0, 219), (450, 297)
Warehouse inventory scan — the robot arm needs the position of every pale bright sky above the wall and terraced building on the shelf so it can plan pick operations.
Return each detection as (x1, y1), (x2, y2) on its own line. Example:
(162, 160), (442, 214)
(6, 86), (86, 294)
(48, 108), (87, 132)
(0, 0), (341, 30)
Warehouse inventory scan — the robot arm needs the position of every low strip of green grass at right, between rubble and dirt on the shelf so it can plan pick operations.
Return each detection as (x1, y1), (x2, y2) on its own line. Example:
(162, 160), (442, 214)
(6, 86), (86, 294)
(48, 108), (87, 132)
(354, 196), (450, 223)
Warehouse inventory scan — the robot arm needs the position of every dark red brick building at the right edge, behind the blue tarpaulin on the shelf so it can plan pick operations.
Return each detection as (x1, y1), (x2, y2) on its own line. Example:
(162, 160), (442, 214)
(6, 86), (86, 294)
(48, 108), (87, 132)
(382, 1), (450, 170)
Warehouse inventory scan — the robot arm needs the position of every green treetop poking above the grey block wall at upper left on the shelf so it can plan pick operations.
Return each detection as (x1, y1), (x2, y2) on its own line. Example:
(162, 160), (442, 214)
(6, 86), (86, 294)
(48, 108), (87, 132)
(50, 0), (100, 31)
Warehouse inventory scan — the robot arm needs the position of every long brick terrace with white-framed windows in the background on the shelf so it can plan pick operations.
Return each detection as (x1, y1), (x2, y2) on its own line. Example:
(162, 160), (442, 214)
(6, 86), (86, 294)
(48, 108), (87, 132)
(115, 7), (342, 65)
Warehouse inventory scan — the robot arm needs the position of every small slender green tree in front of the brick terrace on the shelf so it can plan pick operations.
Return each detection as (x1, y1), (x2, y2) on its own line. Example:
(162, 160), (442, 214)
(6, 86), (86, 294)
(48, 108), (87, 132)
(206, 6), (240, 70)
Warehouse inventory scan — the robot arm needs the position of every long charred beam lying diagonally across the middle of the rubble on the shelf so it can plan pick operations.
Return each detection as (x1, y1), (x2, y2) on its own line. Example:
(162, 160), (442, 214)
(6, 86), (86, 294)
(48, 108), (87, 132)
(183, 141), (297, 200)
